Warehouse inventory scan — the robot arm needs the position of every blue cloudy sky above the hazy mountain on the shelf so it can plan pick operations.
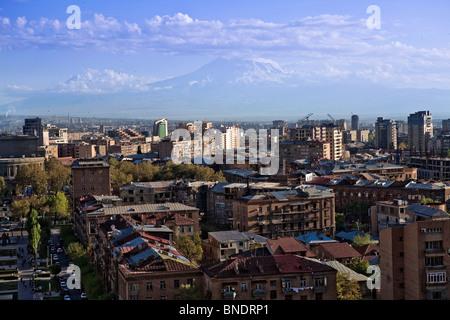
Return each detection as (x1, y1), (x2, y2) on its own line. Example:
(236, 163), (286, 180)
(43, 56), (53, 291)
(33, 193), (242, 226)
(0, 0), (450, 120)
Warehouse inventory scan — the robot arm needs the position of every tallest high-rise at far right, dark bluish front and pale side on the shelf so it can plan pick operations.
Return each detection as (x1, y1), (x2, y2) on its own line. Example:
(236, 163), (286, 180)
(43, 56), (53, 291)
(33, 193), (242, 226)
(408, 111), (433, 151)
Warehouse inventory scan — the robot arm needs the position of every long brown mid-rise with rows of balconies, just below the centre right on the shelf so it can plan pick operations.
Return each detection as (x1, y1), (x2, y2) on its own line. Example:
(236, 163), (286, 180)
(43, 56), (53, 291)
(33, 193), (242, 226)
(232, 185), (335, 239)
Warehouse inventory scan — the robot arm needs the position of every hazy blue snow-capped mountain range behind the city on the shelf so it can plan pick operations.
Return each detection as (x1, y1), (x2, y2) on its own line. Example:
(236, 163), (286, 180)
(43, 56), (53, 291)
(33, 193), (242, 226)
(0, 58), (450, 120)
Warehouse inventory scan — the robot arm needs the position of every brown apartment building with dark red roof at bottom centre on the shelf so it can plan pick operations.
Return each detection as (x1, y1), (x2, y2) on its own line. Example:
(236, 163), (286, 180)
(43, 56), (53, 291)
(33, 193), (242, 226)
(201, 254), (337, 301)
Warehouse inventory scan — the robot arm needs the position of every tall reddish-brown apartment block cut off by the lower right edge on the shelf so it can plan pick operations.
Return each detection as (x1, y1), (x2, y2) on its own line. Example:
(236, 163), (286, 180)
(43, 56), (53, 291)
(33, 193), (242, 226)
(380, 216), (450, 300)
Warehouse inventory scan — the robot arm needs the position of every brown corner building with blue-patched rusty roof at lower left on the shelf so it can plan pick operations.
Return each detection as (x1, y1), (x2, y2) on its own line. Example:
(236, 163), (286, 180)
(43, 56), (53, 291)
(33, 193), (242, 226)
(93, 218), (201, 300)
